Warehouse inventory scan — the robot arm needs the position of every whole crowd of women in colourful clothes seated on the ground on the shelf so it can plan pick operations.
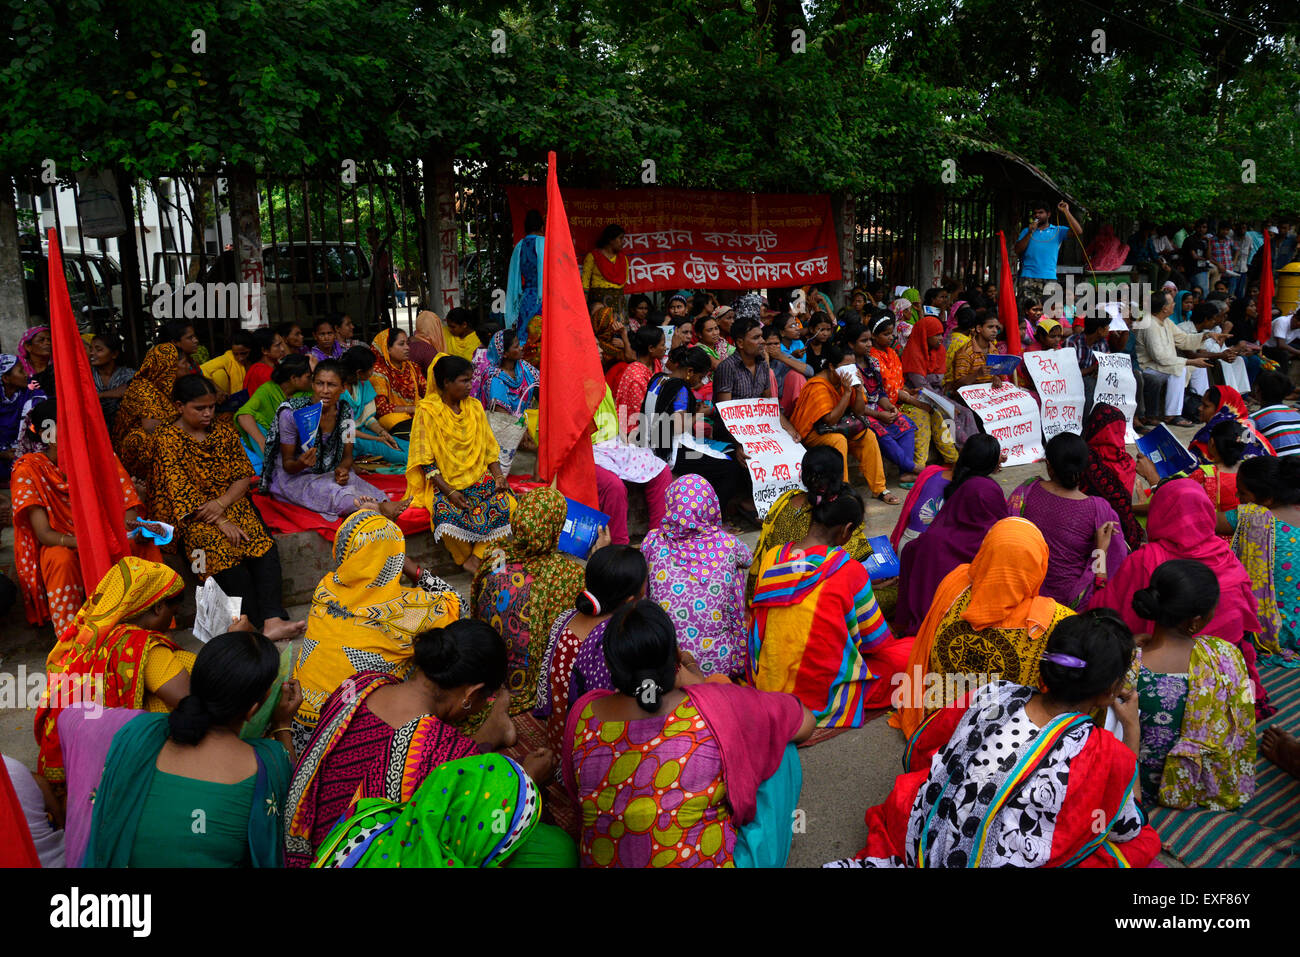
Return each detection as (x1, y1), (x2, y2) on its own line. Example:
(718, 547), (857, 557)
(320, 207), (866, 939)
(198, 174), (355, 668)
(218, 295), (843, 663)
(0, 282), (1300, 867)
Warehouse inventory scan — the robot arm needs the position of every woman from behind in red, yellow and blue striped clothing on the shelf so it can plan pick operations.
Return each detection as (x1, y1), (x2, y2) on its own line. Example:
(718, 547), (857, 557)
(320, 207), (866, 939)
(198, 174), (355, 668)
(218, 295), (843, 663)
(749, 480), (911, 728)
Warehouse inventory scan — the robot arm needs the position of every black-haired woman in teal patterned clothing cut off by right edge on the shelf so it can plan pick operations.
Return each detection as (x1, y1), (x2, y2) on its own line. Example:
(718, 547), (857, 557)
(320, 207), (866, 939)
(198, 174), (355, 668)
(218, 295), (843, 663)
(1216, 455), (1300, 658)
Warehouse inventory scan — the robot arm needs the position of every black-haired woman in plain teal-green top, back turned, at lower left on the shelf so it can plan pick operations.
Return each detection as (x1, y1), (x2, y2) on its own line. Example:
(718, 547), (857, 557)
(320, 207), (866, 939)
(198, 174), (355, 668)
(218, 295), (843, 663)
(82, 632), (302, 867)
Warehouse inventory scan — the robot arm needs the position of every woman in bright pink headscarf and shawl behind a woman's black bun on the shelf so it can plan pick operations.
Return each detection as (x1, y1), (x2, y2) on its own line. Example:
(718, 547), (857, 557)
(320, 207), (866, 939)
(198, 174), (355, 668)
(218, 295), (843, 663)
(1088, 479), (1277, 718)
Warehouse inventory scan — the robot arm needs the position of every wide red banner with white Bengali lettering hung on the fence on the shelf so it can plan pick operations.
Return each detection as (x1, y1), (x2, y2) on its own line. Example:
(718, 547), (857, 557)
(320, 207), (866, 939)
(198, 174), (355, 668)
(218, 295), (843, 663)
(506, 186), (842, 293)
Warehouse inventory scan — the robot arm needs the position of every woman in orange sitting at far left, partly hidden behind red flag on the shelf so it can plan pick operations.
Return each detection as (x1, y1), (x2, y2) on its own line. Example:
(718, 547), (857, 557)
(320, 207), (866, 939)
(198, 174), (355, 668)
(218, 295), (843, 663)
(10, 399), (163, 637)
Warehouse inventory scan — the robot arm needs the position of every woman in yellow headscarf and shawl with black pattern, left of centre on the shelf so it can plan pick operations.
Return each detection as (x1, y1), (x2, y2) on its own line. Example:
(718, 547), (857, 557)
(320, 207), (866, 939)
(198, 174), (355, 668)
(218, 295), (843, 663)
(291, 510), (460, 753)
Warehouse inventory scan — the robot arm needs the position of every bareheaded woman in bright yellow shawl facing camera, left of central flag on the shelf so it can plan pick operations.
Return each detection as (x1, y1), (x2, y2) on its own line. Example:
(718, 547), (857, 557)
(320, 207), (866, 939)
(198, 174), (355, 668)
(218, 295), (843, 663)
(407, 355), (515, 572)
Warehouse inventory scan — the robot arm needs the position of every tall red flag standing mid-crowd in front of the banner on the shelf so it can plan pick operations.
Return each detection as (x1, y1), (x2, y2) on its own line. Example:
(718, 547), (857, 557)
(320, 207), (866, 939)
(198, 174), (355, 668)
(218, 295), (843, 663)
(537, 152), (605, 508)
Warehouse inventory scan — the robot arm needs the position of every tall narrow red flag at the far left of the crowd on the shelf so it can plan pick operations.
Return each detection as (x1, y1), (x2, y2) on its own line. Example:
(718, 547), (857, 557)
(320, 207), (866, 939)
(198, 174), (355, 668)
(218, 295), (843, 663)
(49, 229), (130, 593)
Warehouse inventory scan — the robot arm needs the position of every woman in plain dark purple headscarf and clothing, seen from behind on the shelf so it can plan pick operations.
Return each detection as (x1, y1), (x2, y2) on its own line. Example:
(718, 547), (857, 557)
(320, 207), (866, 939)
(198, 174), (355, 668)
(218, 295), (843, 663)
(893, 473), (1006, 636)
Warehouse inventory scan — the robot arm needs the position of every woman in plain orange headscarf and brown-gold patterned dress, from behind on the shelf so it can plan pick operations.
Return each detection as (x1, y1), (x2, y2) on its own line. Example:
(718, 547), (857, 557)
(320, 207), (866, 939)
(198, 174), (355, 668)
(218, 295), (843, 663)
(891, 518), (1074, 737)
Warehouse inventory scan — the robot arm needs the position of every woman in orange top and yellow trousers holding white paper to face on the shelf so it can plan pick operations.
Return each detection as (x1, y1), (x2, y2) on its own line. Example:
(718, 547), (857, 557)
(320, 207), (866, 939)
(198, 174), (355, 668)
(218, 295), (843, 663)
(790, 342), (900, 505)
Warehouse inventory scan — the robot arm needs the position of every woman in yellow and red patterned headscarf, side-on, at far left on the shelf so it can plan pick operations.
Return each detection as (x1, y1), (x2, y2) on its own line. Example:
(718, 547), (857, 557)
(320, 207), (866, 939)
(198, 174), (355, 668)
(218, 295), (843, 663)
(35, 557), (196, 781)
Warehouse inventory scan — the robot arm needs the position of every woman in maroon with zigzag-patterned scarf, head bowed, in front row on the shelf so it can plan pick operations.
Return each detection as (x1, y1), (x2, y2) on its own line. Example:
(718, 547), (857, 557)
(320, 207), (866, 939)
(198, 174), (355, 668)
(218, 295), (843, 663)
(285, 619), (555, 867)
